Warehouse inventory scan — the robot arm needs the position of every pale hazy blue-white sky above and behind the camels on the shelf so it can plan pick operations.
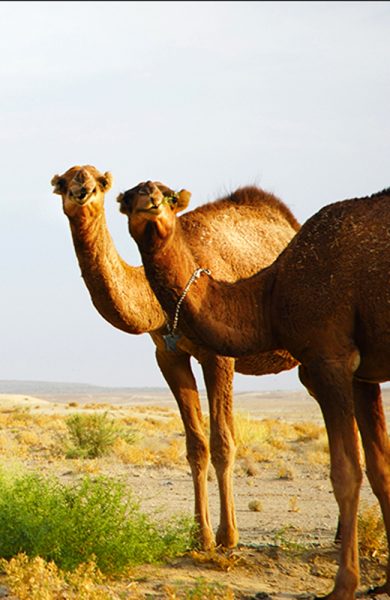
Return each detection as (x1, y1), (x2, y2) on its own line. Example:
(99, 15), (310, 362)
(0, 0), (390, 392)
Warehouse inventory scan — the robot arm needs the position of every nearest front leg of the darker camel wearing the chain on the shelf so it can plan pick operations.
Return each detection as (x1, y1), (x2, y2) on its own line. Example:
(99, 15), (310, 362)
(302, 359), (362, 600)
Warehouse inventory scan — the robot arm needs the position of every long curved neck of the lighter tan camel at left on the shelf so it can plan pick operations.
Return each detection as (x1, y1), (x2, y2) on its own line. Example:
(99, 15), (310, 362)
(69, 208), (165, 334)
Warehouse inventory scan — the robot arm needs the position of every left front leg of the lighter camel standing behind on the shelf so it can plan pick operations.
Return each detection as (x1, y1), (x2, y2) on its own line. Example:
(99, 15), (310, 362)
(156, 348), (215, 550)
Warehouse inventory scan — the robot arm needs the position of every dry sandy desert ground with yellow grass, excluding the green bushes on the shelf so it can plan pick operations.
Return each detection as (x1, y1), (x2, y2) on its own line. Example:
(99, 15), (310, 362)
(0, 389), (390, 600)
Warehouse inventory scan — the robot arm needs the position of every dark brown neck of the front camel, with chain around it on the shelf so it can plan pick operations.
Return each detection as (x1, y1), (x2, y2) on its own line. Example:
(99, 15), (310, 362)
(141, 222), (276, 356)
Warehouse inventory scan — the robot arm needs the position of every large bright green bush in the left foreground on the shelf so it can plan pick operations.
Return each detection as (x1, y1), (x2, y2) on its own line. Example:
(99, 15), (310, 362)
(0, 473), (193, 574)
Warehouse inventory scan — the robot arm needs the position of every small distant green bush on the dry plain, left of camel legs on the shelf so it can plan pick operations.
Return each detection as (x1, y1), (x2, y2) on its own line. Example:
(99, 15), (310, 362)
(66, 413), (135, 458)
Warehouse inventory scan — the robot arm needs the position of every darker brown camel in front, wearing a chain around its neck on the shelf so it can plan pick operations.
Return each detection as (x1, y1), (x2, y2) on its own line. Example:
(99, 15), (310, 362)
(119, 182), (390, 600)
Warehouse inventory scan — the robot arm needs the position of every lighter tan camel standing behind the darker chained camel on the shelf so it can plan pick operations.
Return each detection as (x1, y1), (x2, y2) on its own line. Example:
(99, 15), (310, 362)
(52, 165), (299, 548)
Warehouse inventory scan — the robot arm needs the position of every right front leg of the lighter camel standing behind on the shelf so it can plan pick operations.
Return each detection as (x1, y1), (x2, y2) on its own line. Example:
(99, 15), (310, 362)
(201, 354), (238, 548)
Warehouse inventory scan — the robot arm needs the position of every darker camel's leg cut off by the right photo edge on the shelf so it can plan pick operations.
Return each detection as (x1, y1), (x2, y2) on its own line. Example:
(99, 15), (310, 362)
(354, 381), (390, 595)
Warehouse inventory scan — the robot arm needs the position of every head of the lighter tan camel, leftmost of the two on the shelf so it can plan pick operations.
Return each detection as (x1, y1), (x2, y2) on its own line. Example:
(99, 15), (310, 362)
(51, 165), (112, 216)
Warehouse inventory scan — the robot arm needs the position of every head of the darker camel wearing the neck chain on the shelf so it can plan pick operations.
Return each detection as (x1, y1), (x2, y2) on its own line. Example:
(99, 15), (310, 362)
(117, 181), (191, 248)
